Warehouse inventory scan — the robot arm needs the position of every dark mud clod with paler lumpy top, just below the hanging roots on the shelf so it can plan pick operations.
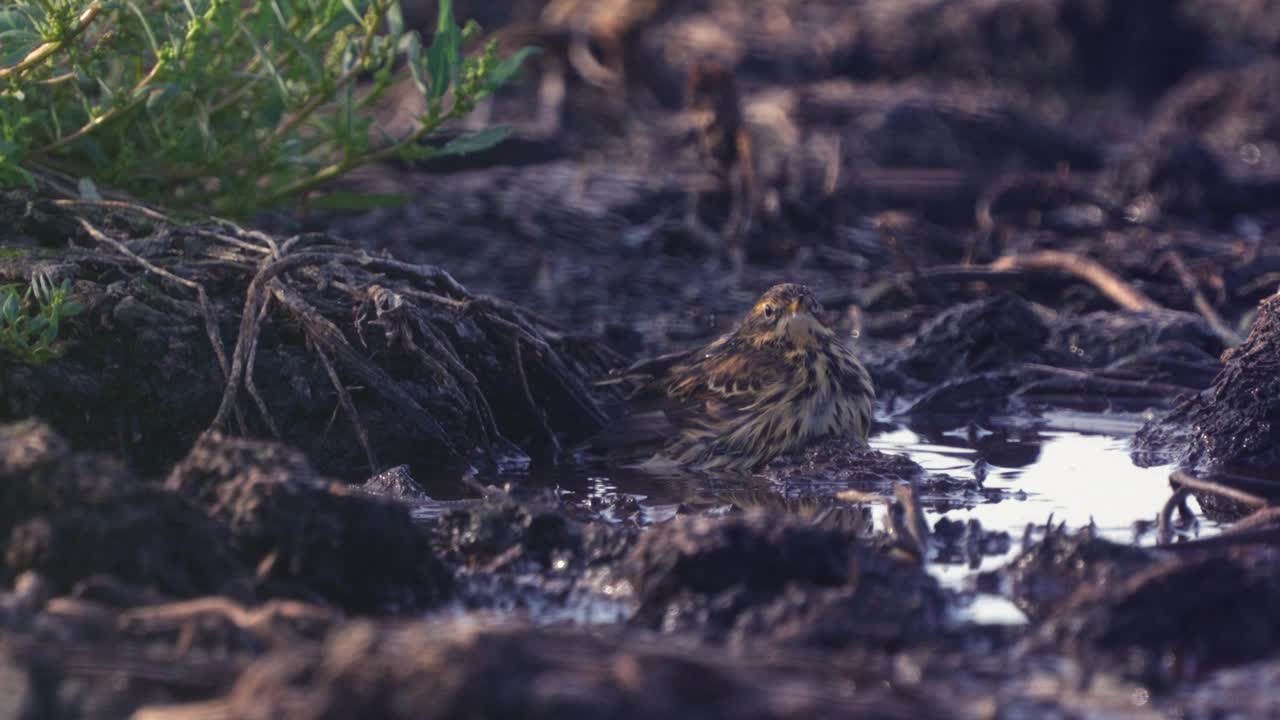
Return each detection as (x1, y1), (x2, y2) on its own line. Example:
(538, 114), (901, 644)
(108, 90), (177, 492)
(165, 433), (451, 612)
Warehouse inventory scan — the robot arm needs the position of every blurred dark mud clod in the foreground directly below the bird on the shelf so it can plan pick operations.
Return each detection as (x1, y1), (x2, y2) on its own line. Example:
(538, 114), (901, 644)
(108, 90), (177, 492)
(626, 511), (943, 647)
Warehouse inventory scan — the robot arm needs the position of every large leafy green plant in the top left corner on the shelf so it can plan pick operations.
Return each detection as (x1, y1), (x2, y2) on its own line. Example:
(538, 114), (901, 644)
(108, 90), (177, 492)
(0, 0), (531, 215)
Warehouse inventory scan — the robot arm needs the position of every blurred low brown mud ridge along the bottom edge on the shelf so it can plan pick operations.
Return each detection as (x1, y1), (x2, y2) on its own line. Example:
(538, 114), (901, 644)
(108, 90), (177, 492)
(228, 624), (940, 720)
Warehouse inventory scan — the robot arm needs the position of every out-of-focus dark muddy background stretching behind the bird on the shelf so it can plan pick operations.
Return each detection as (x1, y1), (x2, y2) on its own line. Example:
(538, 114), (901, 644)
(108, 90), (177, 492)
(306, 0), (1280, 354)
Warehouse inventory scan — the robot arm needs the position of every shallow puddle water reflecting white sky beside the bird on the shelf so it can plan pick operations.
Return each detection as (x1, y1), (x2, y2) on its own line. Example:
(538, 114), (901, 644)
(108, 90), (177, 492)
(412, 413), (1198, 623)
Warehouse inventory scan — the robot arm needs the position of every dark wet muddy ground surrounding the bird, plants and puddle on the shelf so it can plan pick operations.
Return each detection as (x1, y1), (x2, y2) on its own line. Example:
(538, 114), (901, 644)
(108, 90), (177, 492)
(0, 0), (1280, 719)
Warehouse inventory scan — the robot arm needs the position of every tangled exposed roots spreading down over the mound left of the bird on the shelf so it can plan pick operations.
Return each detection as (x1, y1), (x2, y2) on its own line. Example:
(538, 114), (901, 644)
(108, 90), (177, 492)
(32, 202), (617, 477)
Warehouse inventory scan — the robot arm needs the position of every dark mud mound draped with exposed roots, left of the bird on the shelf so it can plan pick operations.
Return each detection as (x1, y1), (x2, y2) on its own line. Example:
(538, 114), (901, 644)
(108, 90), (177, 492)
(0, 196), (611, 479)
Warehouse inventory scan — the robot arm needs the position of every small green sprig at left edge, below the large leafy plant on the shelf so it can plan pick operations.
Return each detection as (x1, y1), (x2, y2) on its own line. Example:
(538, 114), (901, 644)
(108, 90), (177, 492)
(0, 267), (84, 365)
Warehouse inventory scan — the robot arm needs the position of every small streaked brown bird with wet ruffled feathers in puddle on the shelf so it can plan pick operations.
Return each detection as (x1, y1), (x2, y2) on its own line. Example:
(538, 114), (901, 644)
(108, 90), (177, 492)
(591, 283), (876, 471)
